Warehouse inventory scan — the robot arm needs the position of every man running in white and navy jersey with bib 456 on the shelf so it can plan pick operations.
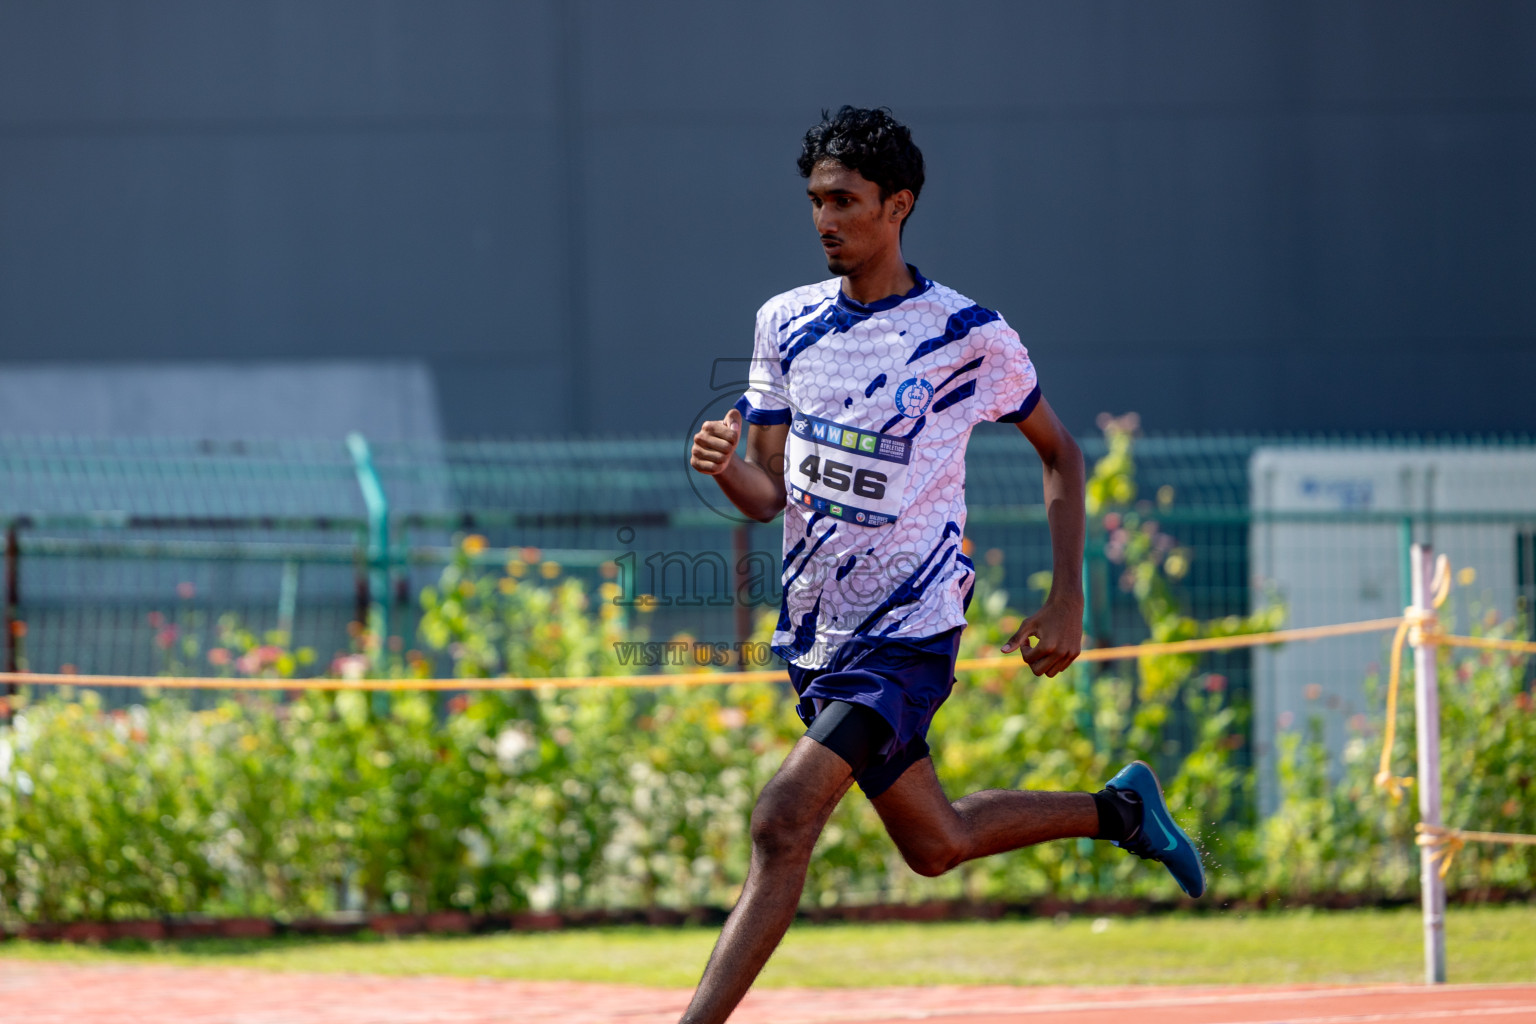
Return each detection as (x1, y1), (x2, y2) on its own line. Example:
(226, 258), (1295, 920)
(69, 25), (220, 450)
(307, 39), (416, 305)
(682, 106), (1204, 1024)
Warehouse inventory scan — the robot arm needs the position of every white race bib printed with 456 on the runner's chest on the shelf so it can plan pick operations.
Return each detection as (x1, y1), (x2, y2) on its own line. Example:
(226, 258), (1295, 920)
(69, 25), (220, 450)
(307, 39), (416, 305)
(785, 413), (912, 527)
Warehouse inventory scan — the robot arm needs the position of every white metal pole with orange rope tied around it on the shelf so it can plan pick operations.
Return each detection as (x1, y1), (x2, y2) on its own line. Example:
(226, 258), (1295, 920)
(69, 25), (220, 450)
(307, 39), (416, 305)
(1412, 543), (1445, 986)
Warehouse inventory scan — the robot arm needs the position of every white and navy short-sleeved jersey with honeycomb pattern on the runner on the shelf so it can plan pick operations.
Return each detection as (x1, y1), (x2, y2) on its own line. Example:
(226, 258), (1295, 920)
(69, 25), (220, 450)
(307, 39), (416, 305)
(737, 267), (1040, 668)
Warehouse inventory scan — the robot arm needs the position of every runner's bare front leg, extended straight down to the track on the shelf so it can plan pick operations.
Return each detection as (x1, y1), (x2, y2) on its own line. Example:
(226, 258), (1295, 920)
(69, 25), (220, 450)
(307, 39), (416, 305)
(682, 737), (852, 1024)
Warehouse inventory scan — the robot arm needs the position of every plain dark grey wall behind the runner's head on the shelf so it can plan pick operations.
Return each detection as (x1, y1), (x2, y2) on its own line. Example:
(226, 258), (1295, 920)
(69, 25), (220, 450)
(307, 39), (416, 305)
(0, 0), (1536, 434)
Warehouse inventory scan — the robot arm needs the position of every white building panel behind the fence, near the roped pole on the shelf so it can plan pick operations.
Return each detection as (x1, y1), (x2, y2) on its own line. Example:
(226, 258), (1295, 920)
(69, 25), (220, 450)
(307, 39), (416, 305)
(1249, 447), (1536, 814)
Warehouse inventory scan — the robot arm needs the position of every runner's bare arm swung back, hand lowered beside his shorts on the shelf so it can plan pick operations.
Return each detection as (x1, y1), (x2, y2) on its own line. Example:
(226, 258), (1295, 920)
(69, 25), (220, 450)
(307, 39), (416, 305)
(1003, 398), (1087, 676)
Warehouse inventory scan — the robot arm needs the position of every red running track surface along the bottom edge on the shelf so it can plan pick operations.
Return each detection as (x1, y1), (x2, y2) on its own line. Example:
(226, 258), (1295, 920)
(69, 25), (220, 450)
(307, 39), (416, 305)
(0, 960), (1536, 1024)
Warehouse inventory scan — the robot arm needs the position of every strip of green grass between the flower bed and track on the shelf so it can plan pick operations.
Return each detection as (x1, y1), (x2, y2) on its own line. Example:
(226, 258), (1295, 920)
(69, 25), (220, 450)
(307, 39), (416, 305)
(0, 906), (1536, 987)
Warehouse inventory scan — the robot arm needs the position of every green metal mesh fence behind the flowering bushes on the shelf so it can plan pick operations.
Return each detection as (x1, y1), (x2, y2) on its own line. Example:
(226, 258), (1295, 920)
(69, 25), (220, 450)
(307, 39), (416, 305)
(0, 428), (1536, 694)
